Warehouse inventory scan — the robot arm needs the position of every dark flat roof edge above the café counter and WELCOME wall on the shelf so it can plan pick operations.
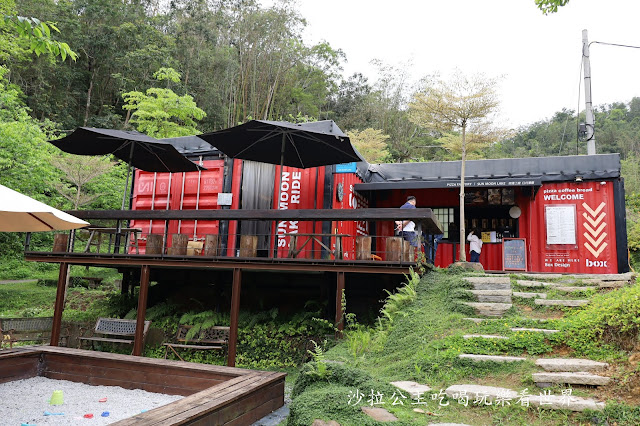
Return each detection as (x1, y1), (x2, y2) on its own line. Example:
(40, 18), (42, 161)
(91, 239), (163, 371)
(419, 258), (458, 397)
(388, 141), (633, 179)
(358, 154), (620, 189)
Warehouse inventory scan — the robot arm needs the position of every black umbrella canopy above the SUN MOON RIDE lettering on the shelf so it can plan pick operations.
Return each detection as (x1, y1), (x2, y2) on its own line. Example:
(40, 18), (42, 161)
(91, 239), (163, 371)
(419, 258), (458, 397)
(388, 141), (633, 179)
(198, 120), (363, 169)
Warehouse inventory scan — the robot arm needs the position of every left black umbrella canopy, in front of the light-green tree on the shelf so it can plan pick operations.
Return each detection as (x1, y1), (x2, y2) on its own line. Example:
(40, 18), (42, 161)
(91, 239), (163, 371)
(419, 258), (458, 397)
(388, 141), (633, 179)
(49, 127), (204, 172)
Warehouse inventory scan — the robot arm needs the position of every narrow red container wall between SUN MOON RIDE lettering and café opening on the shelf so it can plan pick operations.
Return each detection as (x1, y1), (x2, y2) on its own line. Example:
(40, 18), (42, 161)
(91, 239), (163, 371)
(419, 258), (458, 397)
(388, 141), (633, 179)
(331, 173), (369, 260)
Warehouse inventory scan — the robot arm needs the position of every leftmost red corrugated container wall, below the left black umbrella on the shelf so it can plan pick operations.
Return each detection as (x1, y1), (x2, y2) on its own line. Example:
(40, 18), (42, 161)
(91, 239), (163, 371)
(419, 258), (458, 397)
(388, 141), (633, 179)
(129, 160), (241, 253)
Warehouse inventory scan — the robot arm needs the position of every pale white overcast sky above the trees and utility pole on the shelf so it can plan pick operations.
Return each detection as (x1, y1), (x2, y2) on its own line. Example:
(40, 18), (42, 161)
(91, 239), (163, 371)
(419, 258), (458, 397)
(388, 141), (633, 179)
(284, 0), (640, 128)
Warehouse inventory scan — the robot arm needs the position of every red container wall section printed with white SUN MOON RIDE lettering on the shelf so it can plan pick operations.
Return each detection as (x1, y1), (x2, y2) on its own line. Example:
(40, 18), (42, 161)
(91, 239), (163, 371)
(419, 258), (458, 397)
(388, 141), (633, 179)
(272, 166), (325, 259)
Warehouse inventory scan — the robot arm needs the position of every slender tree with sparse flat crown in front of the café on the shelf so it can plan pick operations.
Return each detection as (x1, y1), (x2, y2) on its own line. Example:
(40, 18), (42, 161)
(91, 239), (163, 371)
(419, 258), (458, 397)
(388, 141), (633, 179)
(409, 71), (499, 262)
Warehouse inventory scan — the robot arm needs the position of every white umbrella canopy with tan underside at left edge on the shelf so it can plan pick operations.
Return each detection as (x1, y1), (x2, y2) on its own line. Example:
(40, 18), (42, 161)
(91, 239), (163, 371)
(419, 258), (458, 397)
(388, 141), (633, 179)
(0, 185), (89, 232)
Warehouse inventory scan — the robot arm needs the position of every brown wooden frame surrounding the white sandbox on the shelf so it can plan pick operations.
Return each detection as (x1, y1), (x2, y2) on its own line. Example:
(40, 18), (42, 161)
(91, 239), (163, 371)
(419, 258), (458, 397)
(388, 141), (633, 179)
(0, 346), (286, 426)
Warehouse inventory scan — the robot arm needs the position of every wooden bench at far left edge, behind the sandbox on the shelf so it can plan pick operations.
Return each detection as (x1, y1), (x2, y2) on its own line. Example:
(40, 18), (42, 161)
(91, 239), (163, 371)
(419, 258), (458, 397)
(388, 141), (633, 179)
(0, 317), (69, 348)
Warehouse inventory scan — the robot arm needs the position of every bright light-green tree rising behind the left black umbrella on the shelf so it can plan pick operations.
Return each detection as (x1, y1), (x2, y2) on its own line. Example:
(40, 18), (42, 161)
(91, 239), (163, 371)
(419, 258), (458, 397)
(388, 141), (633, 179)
(122, 68), (206, 138)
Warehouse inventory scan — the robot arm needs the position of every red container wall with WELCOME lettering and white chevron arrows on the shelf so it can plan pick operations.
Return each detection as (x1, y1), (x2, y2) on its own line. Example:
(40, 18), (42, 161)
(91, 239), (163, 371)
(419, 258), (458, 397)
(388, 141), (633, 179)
(521, 182), (618, 274)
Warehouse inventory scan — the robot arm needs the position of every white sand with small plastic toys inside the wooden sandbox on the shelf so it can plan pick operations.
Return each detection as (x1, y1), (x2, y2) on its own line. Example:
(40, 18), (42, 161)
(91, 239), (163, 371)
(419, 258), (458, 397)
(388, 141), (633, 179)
(0, 377), (182, 426)
